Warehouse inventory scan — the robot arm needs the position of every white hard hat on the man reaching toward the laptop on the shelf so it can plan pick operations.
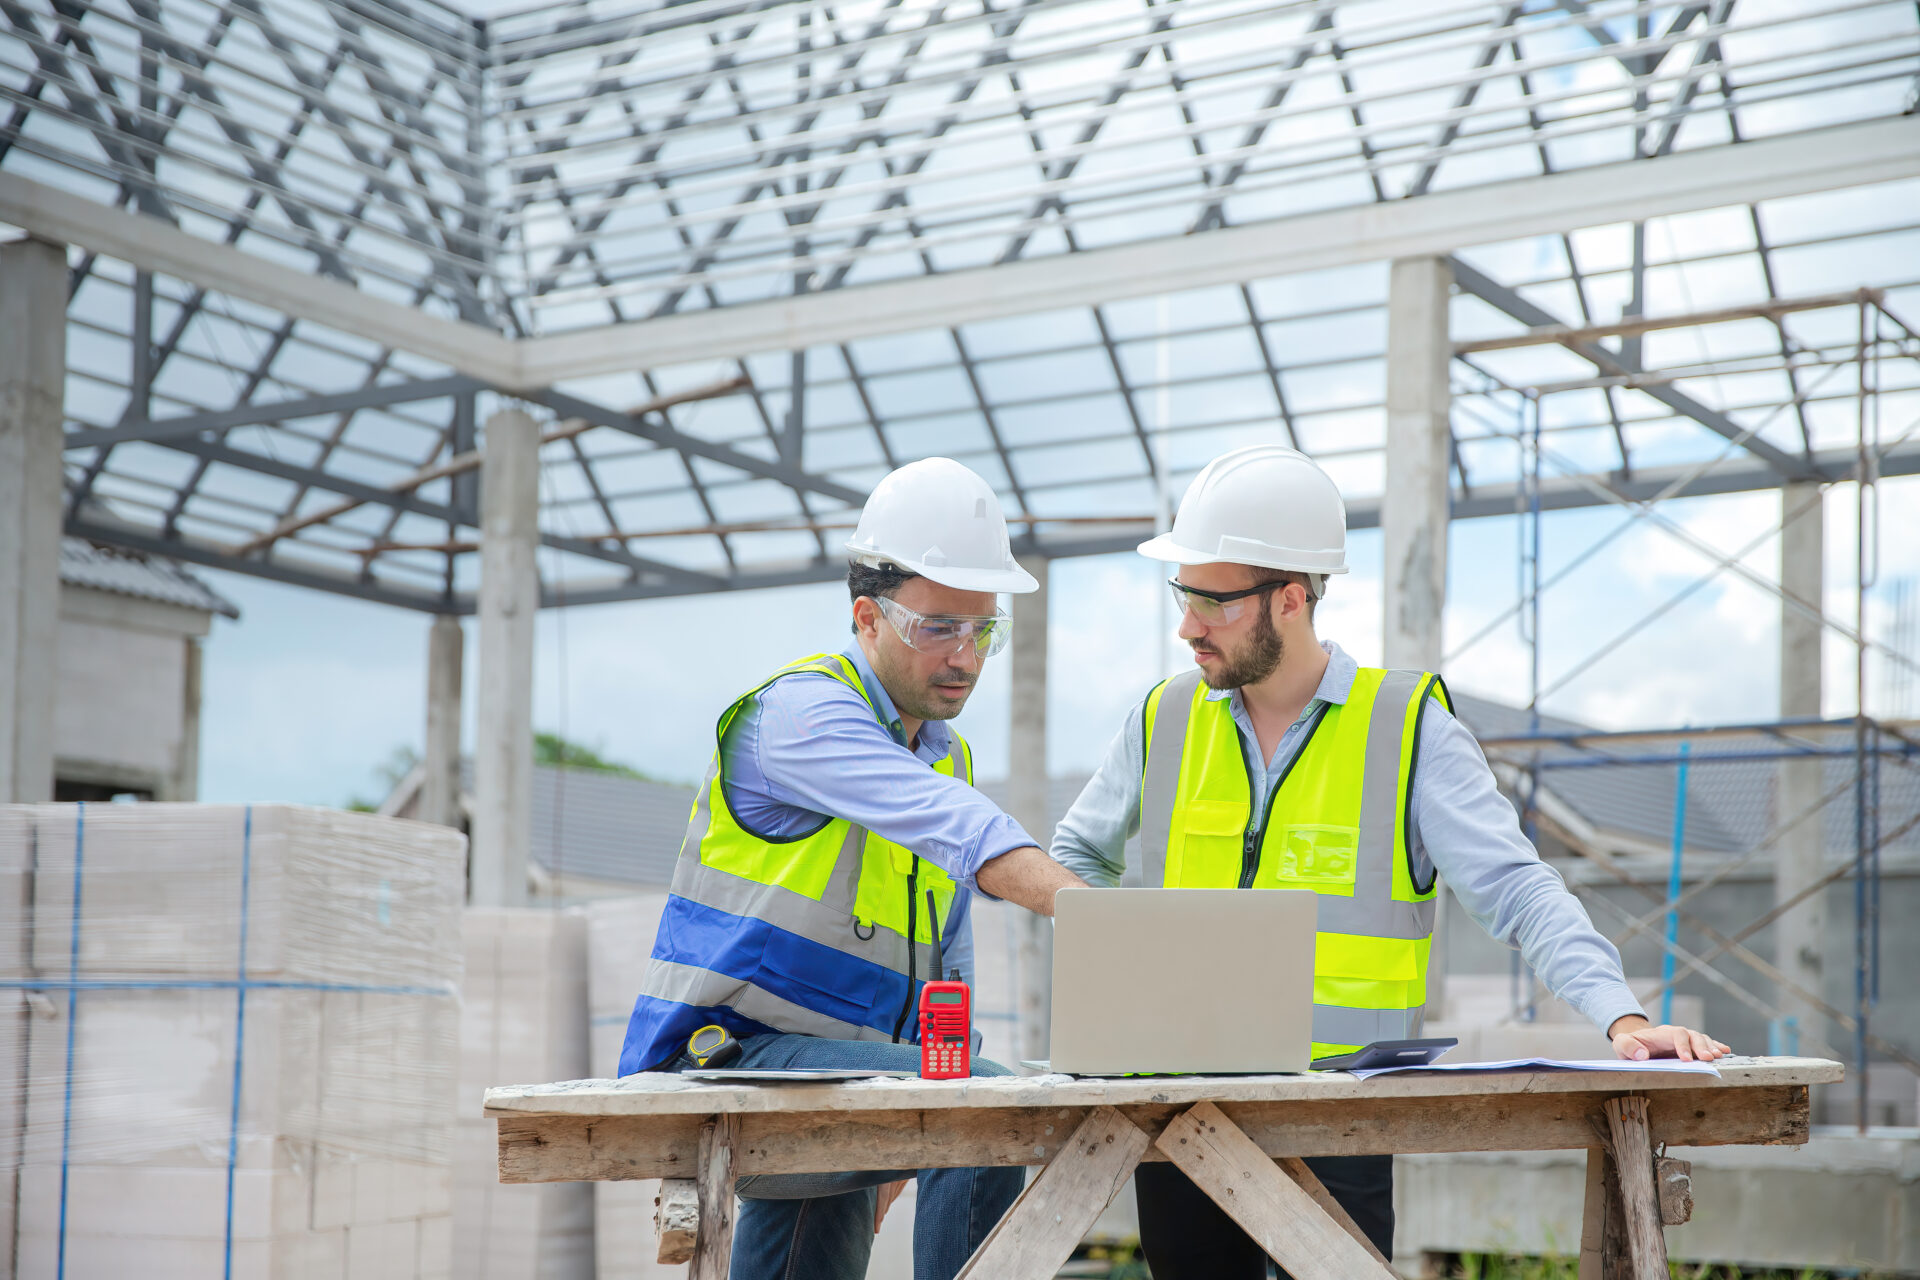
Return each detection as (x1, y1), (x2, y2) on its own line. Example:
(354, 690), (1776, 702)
(847, 459), (1041, 595)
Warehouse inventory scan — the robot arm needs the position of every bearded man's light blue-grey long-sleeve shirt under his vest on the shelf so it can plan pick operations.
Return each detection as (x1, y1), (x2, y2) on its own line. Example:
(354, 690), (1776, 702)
(1052, 643), (1644, 1031)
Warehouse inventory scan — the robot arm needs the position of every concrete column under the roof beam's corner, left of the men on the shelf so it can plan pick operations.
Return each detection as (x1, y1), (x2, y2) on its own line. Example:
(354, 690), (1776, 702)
(470, 409), (540, 906)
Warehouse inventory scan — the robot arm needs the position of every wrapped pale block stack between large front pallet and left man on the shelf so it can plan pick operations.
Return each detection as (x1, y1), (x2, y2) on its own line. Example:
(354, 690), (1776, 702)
(453, 908), (593, 1280)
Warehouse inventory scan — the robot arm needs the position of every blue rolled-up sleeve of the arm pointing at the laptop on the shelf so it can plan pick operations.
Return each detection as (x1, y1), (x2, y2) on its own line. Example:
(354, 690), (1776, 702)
(728, 672), (1035, 892)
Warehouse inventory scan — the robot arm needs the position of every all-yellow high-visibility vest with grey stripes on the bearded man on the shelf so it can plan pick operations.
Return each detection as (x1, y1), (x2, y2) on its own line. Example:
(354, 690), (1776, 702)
(1140, 668), (1452, 1057)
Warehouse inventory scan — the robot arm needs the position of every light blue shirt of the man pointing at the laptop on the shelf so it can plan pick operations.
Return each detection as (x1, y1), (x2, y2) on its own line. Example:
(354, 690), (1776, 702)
(720, 645), (1039, 984)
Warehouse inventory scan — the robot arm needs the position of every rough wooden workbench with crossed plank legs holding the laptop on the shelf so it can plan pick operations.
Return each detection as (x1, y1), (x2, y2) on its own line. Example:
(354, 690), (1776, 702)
(486, 1057), (1841, 1280)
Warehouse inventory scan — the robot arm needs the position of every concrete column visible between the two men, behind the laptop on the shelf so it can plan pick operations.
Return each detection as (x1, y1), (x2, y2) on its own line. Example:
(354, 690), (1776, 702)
(1006, 557), (1054, 1057)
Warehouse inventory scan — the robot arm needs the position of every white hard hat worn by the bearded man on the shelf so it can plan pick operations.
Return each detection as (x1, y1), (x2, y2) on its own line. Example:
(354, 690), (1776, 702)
(1140, 445), (1346, 579)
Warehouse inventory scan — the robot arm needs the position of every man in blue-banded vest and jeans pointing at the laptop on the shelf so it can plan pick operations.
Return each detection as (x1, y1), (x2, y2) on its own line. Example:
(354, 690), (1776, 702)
(620, 459), (1081, 1280)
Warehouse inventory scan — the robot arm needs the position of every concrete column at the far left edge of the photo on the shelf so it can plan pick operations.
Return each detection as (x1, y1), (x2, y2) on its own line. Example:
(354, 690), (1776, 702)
(0, 240), (67, 802)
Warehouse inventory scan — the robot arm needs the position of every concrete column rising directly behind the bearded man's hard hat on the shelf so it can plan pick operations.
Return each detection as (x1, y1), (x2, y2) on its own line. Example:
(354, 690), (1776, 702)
(1380, 257), (1453, 672)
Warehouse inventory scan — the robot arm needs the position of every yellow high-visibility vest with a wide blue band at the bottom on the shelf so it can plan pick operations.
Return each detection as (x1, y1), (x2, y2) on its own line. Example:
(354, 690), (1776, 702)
(620, 654), (973, 1075)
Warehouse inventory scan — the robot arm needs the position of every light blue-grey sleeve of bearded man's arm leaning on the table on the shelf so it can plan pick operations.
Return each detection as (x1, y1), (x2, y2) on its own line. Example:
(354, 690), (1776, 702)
(1411, 702), (1644, 1031)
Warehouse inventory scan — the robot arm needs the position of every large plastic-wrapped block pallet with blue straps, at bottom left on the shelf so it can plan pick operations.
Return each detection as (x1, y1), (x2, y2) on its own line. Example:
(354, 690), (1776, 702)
(0, 804), (465, 1280)
